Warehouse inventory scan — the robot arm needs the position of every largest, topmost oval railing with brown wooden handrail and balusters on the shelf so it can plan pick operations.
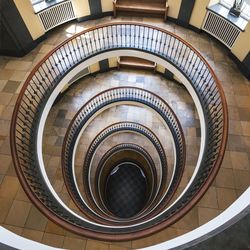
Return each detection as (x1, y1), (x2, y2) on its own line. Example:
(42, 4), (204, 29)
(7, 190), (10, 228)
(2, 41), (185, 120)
(10, 22), (228, 240)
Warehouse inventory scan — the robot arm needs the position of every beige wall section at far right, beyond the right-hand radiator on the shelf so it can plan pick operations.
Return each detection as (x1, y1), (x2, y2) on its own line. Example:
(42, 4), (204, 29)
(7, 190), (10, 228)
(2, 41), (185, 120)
(231, 22), (250, 61)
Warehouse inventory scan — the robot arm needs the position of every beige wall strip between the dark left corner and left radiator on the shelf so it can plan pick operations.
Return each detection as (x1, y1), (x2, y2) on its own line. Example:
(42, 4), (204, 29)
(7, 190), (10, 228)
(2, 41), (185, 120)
(14, 0), (44, 40)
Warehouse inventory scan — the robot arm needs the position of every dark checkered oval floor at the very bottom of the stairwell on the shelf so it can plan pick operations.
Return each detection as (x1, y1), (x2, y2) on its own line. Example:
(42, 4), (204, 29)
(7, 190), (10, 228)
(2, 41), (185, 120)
(105, 162), (149, 219)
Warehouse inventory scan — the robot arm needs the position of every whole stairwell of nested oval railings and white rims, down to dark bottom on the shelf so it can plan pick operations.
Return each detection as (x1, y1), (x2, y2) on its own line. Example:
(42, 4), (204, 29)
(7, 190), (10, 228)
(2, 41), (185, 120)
(11, 22), (228, 244)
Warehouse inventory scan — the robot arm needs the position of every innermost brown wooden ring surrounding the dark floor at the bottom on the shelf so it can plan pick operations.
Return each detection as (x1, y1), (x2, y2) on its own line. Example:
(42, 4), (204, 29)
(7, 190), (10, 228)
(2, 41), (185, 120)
(95, 143), (158, 221)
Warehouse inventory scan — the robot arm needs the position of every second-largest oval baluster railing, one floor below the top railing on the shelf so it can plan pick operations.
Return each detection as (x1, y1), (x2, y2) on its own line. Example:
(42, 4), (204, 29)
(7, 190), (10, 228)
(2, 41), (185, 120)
(62, 87), (185, 223)
